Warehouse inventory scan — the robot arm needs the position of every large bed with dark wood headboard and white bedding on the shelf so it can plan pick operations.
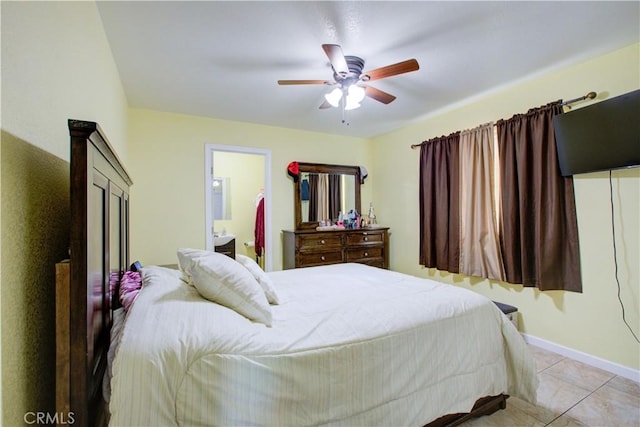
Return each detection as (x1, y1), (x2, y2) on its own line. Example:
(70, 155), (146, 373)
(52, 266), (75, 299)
(56, 122), (537, 426)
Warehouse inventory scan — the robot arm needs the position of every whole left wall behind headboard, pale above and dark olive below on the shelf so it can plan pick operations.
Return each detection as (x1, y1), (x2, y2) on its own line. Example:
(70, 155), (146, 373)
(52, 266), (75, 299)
(0, 2), (127, 426)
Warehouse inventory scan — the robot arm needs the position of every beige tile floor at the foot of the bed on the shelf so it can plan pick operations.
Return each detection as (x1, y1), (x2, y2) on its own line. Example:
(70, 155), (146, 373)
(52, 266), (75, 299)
(463, 345), (640, 427)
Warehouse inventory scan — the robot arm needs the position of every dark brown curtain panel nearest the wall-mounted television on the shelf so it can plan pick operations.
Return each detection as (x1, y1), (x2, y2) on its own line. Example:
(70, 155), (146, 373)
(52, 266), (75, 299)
(497, 102), (582, 292)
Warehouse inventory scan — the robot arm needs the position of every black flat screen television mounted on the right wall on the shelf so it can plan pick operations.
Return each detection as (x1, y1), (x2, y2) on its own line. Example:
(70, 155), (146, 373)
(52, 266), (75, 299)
(553, 90), (640, 176)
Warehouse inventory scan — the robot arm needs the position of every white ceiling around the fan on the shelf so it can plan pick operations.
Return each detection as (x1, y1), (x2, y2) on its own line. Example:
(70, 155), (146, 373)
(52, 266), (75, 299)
(98, 1), (640, 137)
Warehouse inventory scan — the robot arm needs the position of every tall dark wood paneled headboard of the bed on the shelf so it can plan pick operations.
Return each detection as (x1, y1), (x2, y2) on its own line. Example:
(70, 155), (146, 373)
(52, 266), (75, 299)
(56, 120), (132, 426)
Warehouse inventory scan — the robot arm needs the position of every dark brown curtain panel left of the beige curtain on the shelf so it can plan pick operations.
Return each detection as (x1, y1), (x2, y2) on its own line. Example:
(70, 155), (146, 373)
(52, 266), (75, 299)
(420, 132), (460, 273)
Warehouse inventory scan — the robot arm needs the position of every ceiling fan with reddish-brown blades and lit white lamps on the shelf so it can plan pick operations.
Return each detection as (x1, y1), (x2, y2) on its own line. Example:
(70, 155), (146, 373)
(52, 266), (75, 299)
(278, 44), (420, 110)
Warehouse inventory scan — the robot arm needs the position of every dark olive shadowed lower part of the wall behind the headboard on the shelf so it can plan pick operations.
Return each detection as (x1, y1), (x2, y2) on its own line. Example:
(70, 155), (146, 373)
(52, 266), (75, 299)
(0, 132), (69, 425)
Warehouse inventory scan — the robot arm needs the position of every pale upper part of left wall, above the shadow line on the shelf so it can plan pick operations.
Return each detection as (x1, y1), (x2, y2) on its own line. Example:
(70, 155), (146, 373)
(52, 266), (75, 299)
(2, 1), (127, 164)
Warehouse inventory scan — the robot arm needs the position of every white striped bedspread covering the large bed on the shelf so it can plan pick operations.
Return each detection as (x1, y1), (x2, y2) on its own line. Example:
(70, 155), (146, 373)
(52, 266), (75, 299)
(110, 264), (537, 426)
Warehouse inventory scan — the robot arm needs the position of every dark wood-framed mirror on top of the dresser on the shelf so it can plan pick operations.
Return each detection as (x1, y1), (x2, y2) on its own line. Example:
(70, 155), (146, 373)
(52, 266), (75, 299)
(294, 163), (360, 230)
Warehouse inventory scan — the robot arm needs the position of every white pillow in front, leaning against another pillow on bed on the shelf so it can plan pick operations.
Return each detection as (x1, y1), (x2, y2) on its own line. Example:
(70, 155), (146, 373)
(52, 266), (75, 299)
(178, 249), (271, 326)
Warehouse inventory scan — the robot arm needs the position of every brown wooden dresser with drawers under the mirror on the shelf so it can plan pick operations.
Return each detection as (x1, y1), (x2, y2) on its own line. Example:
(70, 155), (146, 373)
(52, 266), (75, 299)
(283, 227), (389, 269)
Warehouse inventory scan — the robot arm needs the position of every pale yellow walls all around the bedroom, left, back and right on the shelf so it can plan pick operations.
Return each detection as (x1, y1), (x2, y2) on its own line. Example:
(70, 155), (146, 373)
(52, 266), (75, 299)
(0, 2), (640, 425)
